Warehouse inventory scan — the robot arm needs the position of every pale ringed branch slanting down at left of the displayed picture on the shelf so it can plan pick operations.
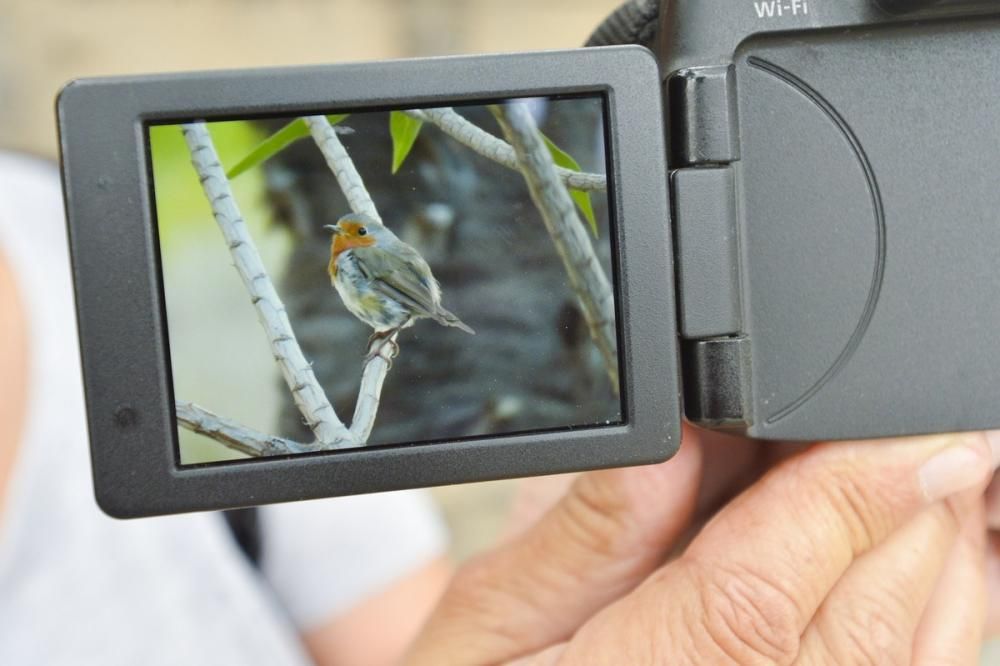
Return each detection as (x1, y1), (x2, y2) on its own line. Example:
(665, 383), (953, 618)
(182, 122), (355, 448)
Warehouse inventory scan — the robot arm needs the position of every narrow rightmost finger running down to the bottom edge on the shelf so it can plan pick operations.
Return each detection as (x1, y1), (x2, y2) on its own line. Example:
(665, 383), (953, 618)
(912, 495), (986, 666)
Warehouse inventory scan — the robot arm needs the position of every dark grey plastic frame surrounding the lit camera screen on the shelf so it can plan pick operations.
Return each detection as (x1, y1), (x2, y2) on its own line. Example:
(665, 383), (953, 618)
(57, 46), (680, 517)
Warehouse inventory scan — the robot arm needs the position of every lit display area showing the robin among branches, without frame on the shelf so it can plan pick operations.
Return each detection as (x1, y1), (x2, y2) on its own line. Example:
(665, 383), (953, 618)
(147, 96), (623, 465)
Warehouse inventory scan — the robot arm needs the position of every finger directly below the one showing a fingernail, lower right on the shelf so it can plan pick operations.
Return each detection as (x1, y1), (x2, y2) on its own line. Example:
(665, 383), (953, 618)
(796, 502), (959, 666)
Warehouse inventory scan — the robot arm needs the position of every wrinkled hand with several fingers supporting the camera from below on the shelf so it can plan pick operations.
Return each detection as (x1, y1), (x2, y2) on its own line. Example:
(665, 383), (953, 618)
(408, 428), (1000, 666)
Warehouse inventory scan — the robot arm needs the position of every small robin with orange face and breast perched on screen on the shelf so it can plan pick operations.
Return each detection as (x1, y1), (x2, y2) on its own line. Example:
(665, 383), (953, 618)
(324, 213), (475, 355)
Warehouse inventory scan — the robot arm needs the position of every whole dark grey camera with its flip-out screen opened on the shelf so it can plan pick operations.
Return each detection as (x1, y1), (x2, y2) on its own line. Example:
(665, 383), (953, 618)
(57, 0), (1000, 517)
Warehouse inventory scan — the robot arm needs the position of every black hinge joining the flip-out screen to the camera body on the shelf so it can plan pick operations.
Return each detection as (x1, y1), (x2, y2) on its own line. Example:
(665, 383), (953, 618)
(668, 66), (752, 428)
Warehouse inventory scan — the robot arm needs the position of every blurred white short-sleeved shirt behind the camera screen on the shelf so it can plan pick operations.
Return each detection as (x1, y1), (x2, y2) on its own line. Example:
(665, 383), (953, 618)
(0, 153), (446, 666)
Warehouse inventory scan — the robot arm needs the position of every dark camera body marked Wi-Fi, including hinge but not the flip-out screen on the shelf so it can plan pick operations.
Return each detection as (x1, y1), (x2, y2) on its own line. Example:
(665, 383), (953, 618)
(660, 0), (1000, 440)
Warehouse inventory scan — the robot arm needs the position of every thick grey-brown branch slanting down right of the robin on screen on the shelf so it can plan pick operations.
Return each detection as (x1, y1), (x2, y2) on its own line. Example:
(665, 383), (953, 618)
(490, 103), (618, 391)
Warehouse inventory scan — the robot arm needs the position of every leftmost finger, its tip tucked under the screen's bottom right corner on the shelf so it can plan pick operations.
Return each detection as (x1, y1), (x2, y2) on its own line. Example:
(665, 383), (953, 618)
(407, 442), (701, 664)
